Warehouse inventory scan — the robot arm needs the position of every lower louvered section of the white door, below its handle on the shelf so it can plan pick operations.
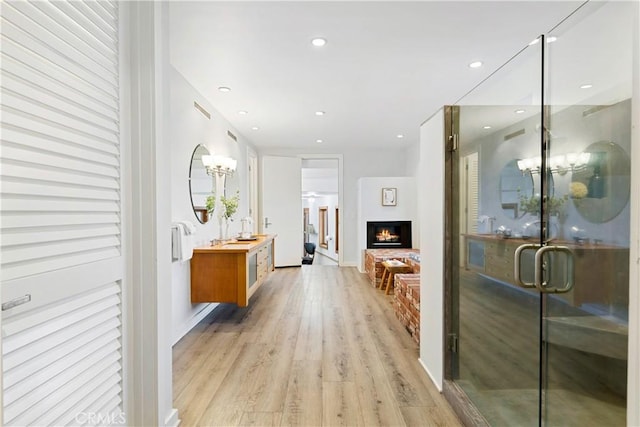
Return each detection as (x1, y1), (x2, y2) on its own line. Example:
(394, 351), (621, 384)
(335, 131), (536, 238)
(3, 283), (121, 426)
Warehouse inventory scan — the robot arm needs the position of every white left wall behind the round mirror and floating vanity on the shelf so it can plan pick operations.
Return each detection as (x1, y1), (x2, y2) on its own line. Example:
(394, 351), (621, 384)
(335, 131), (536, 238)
(167, 67), (255, 344)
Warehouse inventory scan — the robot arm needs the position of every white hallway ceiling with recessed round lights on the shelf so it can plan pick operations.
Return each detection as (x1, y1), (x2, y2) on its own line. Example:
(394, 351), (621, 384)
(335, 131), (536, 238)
(170, 1), (581, 152)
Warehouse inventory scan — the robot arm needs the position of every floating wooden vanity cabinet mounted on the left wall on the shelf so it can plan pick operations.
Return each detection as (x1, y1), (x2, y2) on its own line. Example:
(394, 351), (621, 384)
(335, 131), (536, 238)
(191, 235), (275, 307)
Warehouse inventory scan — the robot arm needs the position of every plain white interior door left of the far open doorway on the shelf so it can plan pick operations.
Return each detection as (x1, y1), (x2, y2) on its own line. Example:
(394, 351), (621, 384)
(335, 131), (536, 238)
(260, 156), (303, 267)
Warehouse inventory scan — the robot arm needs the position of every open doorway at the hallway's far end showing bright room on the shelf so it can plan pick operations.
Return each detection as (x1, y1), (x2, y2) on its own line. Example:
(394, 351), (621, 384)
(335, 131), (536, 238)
(302, 158), (340, 265)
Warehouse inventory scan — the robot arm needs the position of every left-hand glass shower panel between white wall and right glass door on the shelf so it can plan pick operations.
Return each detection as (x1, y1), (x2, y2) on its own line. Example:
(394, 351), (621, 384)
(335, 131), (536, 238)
(452, 35), (549, 426)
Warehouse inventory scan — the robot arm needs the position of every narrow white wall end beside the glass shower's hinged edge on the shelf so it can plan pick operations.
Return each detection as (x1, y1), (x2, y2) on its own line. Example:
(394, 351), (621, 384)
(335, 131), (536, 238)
(417, 110), (445, 390)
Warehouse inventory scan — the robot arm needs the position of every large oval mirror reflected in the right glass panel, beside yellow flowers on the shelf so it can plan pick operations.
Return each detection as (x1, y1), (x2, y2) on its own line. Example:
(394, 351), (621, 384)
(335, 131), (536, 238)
(570, 141), (631, 224)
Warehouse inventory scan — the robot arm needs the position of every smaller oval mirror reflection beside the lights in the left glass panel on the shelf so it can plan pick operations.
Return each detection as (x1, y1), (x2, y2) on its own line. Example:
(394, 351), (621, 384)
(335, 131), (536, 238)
(500, 159), (533, 219)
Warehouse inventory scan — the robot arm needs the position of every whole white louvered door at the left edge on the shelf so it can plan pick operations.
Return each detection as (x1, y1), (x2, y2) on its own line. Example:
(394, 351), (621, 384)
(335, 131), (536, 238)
(0, 1), (125, 426)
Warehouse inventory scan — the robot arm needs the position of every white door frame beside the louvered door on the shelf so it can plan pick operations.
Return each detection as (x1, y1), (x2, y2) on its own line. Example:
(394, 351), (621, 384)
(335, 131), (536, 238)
(120, 2), (180, 426)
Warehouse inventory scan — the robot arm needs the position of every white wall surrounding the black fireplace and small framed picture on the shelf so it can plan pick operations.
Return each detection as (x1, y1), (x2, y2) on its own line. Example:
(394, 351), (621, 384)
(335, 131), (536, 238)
(357, 177), (420, 273)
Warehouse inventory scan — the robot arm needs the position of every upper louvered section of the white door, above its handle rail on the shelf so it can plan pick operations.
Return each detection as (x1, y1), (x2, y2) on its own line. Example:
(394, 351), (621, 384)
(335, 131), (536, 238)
(1, 1), (120, 280)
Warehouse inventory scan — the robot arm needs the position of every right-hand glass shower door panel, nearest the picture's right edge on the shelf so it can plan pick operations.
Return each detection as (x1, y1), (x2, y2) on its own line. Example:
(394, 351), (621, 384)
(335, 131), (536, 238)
(542, 2), (637, 426)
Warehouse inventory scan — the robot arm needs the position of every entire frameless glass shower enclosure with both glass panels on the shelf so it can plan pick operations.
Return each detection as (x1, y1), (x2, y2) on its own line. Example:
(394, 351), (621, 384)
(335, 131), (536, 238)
(445, 2), (633, 426)
